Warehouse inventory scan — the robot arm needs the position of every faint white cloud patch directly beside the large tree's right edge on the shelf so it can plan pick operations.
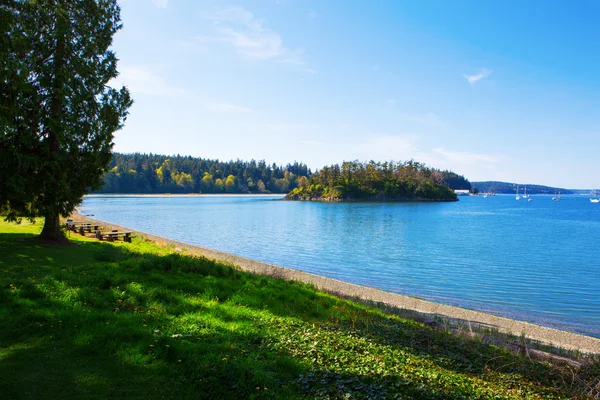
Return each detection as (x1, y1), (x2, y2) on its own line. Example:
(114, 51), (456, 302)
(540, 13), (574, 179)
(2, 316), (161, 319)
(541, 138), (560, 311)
(111, 66), (187, 95)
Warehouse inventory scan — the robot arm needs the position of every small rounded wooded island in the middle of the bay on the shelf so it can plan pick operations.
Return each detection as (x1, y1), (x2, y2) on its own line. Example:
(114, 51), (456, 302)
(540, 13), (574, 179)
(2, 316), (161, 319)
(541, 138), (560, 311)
(285, 160), (460, 201)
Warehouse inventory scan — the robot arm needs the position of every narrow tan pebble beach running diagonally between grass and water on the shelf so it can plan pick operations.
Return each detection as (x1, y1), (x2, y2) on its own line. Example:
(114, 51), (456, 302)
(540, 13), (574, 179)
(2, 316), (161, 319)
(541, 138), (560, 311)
(72, 209), (600, 354)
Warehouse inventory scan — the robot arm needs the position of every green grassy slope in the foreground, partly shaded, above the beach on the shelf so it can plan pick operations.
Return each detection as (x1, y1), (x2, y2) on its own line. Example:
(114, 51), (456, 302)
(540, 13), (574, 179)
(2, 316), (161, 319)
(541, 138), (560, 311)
(0, 222), (600, 399)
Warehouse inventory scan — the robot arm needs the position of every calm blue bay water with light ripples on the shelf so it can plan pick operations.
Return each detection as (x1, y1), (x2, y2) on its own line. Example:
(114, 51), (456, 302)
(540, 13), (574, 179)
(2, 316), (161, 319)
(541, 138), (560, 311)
(82, 196), (600, 337)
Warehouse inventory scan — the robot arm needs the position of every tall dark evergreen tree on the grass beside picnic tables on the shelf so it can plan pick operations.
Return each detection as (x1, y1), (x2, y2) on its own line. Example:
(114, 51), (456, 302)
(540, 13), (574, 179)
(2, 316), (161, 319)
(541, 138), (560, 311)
(0, 0), (132, 240)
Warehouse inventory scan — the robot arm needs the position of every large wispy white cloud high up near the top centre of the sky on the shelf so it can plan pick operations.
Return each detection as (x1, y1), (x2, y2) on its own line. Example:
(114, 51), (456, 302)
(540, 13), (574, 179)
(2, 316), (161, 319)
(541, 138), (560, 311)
(196, 6), (304, 64)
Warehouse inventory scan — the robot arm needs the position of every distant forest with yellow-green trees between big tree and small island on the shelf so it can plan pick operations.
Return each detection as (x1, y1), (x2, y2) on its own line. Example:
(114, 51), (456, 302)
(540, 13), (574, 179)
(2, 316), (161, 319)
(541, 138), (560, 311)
(95, 153), (311, 194)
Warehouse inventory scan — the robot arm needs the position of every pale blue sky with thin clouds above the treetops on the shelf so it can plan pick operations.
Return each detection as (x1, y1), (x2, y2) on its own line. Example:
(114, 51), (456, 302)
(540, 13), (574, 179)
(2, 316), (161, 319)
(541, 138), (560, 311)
(111, 0), (600, 189)
